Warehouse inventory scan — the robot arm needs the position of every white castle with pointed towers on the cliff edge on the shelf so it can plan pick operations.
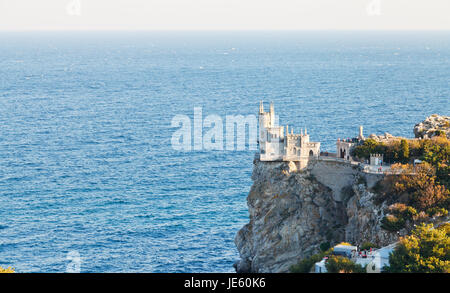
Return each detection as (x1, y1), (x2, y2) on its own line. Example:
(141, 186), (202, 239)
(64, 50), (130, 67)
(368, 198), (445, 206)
(259, 101), (320, 168)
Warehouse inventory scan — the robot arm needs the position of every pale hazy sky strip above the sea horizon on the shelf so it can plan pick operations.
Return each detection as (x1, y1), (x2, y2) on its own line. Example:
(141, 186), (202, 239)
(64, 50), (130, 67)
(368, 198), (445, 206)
(0, 0), (450, 30)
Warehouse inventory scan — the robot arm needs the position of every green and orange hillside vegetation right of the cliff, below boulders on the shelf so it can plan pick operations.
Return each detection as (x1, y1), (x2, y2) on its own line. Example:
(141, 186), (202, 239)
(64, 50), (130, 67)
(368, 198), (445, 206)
(353, 134), (450, 231)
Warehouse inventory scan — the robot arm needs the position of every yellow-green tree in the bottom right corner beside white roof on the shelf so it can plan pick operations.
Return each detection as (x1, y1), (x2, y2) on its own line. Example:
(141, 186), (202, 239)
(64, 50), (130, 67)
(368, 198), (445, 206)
(387, 224), (450, 273)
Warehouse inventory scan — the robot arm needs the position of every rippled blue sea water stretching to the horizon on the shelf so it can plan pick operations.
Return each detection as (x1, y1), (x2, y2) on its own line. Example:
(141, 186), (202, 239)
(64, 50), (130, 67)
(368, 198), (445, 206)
(0, 32), (450, 272)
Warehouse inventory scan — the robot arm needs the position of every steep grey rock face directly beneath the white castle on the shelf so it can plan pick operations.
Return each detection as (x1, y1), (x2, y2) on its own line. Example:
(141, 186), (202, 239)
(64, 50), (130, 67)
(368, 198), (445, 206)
(235, 159), (402, 272)
